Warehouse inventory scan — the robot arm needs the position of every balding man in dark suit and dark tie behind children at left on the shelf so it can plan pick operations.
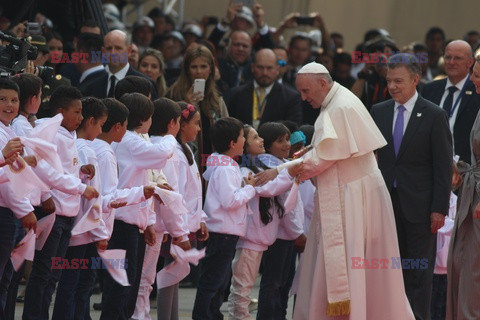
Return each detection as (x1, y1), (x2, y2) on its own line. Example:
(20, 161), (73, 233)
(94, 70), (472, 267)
(79, 30), (158, 99)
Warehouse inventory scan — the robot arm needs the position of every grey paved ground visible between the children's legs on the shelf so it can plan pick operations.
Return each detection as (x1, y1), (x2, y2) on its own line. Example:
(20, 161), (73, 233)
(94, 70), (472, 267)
(15, 279), (293, 320)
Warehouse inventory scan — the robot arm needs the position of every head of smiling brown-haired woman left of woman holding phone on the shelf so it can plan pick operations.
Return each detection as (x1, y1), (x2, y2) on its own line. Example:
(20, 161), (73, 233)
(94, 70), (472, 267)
(138, 49), (167, 98)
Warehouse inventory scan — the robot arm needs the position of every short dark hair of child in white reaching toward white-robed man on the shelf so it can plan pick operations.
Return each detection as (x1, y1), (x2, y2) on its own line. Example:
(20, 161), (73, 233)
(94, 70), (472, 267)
(210, 117), (243, 153)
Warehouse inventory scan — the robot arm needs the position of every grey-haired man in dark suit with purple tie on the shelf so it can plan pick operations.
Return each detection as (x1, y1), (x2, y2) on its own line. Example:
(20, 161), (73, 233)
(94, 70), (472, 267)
(371, 53), (453, 320)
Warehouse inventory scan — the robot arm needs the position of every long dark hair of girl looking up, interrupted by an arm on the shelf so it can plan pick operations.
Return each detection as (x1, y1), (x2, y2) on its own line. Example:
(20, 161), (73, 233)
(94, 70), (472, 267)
(242, 125), (285, 225)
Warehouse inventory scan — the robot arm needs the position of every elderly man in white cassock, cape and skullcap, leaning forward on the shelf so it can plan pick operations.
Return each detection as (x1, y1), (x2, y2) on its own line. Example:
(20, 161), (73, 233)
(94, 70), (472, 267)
(293, 62), (414, 320)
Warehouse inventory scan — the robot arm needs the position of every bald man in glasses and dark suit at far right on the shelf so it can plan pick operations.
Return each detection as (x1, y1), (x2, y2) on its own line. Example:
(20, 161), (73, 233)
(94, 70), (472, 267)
(422, 40), (480, 163)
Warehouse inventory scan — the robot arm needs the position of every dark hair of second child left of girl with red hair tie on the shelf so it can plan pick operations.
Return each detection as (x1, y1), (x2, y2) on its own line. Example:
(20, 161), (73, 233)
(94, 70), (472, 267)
(120, 92), (153, 130)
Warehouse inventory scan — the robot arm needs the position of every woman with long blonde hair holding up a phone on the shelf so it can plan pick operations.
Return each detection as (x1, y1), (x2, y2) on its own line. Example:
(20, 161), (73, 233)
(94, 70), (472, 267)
(166, 46), (228, 154)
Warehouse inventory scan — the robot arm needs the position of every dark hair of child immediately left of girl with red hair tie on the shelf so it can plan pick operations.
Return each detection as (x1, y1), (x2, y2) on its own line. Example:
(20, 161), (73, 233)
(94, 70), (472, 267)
(148, 98), (182, 136)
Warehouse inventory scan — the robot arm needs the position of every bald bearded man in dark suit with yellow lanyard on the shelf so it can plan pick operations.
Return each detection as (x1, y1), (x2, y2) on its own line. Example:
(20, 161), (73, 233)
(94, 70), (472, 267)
(226, 49), (302, 127)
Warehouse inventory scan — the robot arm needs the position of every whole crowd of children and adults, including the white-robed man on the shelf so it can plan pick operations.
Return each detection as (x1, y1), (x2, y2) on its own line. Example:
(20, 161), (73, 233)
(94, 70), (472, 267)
(0, 1), (480, 320)
